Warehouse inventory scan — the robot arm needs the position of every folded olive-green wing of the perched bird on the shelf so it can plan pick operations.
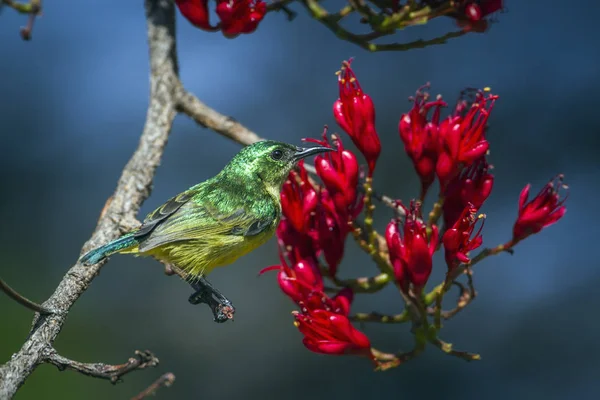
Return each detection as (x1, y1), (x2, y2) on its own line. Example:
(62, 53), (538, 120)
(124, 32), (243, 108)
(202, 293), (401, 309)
(136, 187), (277, 252)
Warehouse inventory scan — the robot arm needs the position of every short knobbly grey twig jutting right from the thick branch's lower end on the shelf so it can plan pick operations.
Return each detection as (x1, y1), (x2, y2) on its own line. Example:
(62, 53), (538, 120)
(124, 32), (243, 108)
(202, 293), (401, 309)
(45, 349), (158, 384)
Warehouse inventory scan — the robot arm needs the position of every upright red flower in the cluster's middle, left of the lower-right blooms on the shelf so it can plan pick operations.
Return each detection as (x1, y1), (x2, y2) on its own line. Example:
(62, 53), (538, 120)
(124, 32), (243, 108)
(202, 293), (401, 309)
(385, 203), (438, 290)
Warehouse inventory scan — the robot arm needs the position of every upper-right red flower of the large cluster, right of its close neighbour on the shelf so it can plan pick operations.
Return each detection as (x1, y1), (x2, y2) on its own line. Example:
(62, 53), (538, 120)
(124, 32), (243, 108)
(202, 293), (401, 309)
(436, 91), (498, 189)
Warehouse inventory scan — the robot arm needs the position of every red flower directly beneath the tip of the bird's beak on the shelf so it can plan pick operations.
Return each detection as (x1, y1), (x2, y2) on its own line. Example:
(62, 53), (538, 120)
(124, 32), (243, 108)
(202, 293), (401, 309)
(306, 127), (362, 218)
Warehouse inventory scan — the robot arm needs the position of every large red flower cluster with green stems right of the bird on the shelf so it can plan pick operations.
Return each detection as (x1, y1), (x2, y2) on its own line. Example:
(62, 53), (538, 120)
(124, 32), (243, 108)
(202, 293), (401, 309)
(265, 58), (566, 369)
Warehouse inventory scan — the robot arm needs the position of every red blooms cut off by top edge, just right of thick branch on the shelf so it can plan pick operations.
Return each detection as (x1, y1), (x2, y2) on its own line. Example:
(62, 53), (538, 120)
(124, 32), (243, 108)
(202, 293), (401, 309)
(175, 0), (267, 38)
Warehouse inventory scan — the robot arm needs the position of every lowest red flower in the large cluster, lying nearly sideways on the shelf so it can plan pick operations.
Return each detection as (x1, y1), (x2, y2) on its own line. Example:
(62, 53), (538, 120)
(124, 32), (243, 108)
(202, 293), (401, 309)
(293, 309), (373, 358)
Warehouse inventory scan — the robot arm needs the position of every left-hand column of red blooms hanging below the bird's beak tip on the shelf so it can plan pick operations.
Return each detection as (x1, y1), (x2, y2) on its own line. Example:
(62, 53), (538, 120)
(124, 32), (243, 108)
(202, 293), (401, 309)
(262, 129), (372, 357)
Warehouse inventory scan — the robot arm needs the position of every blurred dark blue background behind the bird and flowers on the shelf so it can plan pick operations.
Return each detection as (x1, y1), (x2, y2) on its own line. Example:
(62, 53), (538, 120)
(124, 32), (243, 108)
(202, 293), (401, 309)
(0, 0), (600, 400)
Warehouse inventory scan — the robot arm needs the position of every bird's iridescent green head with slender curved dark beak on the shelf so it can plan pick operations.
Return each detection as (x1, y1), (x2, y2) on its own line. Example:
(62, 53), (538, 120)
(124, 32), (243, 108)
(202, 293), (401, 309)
(226, 140), (333, 187)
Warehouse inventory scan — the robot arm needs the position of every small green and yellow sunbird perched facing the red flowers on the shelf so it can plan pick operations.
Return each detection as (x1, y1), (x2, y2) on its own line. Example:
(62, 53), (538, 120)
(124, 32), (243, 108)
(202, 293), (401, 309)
(80, 140), (332, 322)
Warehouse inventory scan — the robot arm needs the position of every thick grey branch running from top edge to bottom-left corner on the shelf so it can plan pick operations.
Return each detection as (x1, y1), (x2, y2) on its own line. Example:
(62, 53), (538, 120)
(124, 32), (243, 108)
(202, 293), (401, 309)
(0, 0), (180, 399)
